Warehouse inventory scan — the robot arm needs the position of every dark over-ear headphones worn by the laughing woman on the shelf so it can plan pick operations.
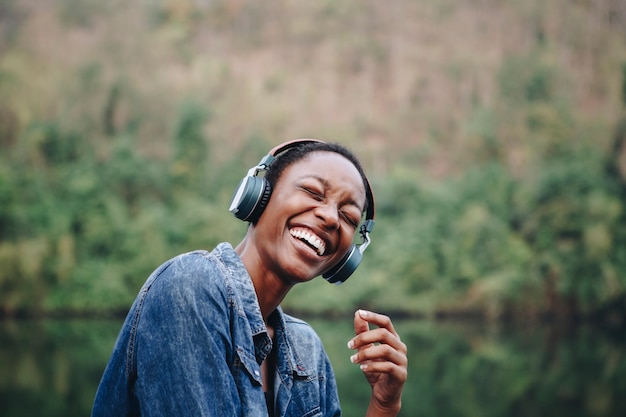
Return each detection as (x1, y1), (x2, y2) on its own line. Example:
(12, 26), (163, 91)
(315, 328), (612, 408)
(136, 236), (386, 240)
(228, 139), (374, 285)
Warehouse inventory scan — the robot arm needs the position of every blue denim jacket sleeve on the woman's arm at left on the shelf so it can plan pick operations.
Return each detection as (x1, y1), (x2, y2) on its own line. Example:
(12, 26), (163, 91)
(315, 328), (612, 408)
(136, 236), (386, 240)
(128, 255), (244, 417)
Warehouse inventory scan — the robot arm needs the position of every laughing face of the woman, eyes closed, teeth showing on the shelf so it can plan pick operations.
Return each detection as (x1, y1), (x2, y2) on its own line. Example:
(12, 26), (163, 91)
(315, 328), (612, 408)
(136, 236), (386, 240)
(255, 151), (366, 283)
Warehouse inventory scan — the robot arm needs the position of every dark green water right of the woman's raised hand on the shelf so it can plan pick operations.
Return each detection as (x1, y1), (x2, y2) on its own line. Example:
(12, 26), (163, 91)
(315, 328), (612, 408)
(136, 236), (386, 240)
(322, 321), (626, 417)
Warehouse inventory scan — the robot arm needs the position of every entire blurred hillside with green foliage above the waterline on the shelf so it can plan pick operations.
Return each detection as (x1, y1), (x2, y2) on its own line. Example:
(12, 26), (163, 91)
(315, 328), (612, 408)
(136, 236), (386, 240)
(0, 0), (626, 317)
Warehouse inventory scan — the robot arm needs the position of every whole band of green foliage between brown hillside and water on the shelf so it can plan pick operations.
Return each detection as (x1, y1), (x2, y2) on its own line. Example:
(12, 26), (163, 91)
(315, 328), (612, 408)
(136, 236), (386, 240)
(0, 99), (626, 317)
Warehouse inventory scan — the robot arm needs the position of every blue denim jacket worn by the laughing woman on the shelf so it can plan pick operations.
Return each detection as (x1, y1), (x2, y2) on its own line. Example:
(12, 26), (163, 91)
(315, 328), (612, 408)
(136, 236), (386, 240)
(92, 243), (341, 417)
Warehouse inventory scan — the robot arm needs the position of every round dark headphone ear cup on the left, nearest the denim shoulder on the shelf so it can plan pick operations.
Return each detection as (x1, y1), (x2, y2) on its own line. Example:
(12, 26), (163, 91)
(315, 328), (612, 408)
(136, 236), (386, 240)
(229, 176), (272, 223)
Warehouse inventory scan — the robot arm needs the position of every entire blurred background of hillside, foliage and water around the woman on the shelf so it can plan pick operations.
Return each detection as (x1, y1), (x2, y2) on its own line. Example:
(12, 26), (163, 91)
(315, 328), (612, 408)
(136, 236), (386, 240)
(0, 0), (626, 416)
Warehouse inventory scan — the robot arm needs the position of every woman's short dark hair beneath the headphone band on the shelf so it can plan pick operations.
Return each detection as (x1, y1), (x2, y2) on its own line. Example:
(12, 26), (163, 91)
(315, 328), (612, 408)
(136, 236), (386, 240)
(265, 142), (374, 212)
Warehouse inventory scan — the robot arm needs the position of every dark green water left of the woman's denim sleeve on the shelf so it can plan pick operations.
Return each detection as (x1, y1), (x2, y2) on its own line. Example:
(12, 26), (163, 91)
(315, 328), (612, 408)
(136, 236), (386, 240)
(0, 320), (120, 417)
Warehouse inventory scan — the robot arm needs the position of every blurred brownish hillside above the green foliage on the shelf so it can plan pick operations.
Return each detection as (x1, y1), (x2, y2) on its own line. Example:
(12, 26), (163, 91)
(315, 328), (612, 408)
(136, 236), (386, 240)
(1, 0), (626, 169)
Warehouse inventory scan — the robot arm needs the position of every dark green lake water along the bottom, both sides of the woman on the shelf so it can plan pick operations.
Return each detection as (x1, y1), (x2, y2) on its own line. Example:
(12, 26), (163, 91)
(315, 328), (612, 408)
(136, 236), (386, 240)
(0, 317), (626, 417)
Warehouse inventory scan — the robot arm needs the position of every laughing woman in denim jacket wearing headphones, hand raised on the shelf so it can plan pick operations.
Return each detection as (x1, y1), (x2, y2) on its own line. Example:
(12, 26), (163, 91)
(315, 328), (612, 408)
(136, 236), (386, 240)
(92, 139), (407, 417)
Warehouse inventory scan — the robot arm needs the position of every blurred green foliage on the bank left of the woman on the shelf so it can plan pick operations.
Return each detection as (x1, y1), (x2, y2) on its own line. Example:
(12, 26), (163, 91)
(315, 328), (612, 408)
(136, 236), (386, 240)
(0, 110), (228, 313)
